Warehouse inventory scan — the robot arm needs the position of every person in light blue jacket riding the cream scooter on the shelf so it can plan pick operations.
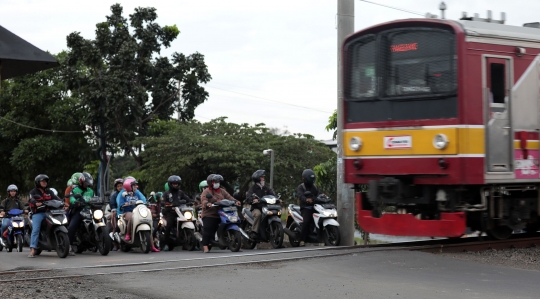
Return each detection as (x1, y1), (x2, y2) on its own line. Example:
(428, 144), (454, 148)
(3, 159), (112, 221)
(116, 178), (159, 252)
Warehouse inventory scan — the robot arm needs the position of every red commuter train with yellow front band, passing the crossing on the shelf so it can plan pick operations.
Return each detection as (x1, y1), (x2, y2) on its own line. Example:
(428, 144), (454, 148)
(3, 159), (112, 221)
(342, 14), (540, 239)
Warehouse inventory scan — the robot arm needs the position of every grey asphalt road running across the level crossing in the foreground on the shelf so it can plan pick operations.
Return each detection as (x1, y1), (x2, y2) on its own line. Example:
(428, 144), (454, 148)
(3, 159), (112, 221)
(0, 247), (540, 299)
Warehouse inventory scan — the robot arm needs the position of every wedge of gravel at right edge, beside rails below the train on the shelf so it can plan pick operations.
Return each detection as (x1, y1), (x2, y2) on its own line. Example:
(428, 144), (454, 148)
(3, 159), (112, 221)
(443, 247), (540, 271)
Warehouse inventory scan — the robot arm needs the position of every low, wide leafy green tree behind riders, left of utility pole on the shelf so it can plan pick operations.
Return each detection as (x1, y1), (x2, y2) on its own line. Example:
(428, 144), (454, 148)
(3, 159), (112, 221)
(137, 117), (335, 200)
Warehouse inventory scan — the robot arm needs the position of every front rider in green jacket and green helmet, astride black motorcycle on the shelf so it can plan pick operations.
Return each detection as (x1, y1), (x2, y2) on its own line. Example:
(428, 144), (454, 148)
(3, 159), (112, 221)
(68, 172), (94, 255)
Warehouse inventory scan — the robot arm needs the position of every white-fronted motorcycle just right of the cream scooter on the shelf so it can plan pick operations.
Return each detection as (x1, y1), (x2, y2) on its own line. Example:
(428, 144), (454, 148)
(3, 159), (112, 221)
(158, 200), (198, 251)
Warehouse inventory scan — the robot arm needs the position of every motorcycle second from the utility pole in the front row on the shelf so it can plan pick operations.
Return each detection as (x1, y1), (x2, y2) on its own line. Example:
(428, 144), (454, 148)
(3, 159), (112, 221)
(242, 194), (284, 249)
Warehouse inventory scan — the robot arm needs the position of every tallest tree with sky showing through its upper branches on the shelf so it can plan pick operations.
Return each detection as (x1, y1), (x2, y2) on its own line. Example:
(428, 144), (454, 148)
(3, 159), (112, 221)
(66, 4), (211, 166)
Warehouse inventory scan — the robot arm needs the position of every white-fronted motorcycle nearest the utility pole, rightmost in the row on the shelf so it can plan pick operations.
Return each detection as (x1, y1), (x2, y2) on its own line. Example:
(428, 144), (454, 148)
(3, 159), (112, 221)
(284, 191), (341, 247)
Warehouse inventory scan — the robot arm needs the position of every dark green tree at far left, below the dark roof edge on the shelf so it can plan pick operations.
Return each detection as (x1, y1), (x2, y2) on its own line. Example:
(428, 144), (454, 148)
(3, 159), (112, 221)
(0, 53), (93, 193)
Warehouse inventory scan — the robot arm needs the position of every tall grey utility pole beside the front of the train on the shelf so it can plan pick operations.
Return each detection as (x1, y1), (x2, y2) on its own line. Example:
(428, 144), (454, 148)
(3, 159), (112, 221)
(337, 0), (355, 246)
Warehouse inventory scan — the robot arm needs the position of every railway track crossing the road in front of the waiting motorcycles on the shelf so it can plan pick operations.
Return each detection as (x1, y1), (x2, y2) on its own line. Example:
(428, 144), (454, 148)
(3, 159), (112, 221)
(0, 235), (540, 283)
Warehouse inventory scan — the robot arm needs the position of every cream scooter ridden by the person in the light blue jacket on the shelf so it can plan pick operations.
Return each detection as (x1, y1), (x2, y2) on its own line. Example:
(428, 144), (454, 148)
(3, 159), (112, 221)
(117, 200), (152, 253)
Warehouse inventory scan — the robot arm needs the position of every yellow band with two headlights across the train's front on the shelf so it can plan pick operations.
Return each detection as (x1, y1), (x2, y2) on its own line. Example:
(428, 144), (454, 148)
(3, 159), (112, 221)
(343, 127), (485, 156)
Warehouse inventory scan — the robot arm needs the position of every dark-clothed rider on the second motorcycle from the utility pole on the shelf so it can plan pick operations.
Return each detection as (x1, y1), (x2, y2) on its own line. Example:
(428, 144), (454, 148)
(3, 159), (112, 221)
(246, 169), (281, 238)
